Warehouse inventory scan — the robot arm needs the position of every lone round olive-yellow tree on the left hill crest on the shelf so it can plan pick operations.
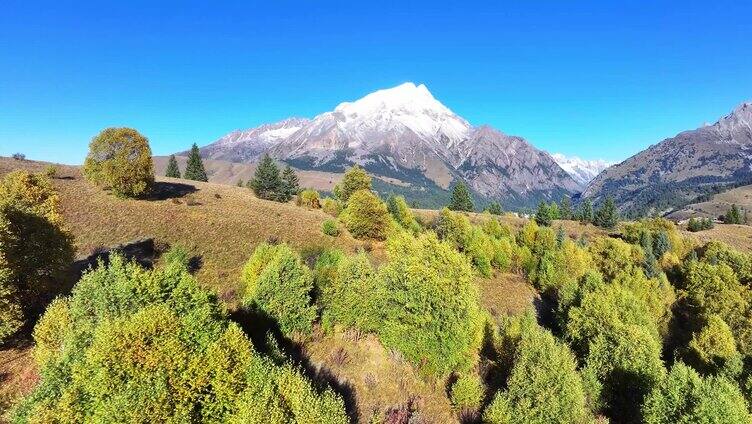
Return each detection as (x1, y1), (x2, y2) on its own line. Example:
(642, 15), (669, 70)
(83, 128), (154, 197)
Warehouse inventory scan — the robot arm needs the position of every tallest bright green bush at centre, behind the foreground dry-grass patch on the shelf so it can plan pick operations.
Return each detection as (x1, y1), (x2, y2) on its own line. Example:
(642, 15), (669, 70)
(378, 233), (482, 375)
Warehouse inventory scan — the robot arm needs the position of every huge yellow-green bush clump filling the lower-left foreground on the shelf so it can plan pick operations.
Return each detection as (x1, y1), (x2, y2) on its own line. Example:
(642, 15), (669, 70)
(12, 255), (348, 424)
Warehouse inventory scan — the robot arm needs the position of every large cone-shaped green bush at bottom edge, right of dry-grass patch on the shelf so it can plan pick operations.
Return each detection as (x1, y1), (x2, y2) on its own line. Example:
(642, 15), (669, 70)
(483, 315), (589, 424)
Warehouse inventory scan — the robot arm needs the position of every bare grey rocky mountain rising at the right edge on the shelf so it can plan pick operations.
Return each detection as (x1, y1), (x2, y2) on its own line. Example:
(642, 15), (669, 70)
(583, 103), (752, 214)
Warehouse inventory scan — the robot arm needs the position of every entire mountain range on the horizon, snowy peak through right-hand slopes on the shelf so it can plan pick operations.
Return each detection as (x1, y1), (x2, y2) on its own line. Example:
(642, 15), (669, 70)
(191, 83), (752, 215)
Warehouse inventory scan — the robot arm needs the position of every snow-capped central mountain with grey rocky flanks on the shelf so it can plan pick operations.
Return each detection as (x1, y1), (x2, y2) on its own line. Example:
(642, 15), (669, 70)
(201, 83), (582, 207)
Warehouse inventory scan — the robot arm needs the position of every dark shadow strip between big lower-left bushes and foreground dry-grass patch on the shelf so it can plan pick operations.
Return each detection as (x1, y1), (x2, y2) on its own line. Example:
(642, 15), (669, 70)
(230, 308), (358, 417)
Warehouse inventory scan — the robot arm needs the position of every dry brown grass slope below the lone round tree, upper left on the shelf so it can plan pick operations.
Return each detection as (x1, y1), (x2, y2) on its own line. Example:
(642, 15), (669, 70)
(0, 158), (376, 306)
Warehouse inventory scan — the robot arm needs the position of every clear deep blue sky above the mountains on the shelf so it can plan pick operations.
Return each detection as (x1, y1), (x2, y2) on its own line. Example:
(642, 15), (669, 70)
(0, 0), (752, 163)
